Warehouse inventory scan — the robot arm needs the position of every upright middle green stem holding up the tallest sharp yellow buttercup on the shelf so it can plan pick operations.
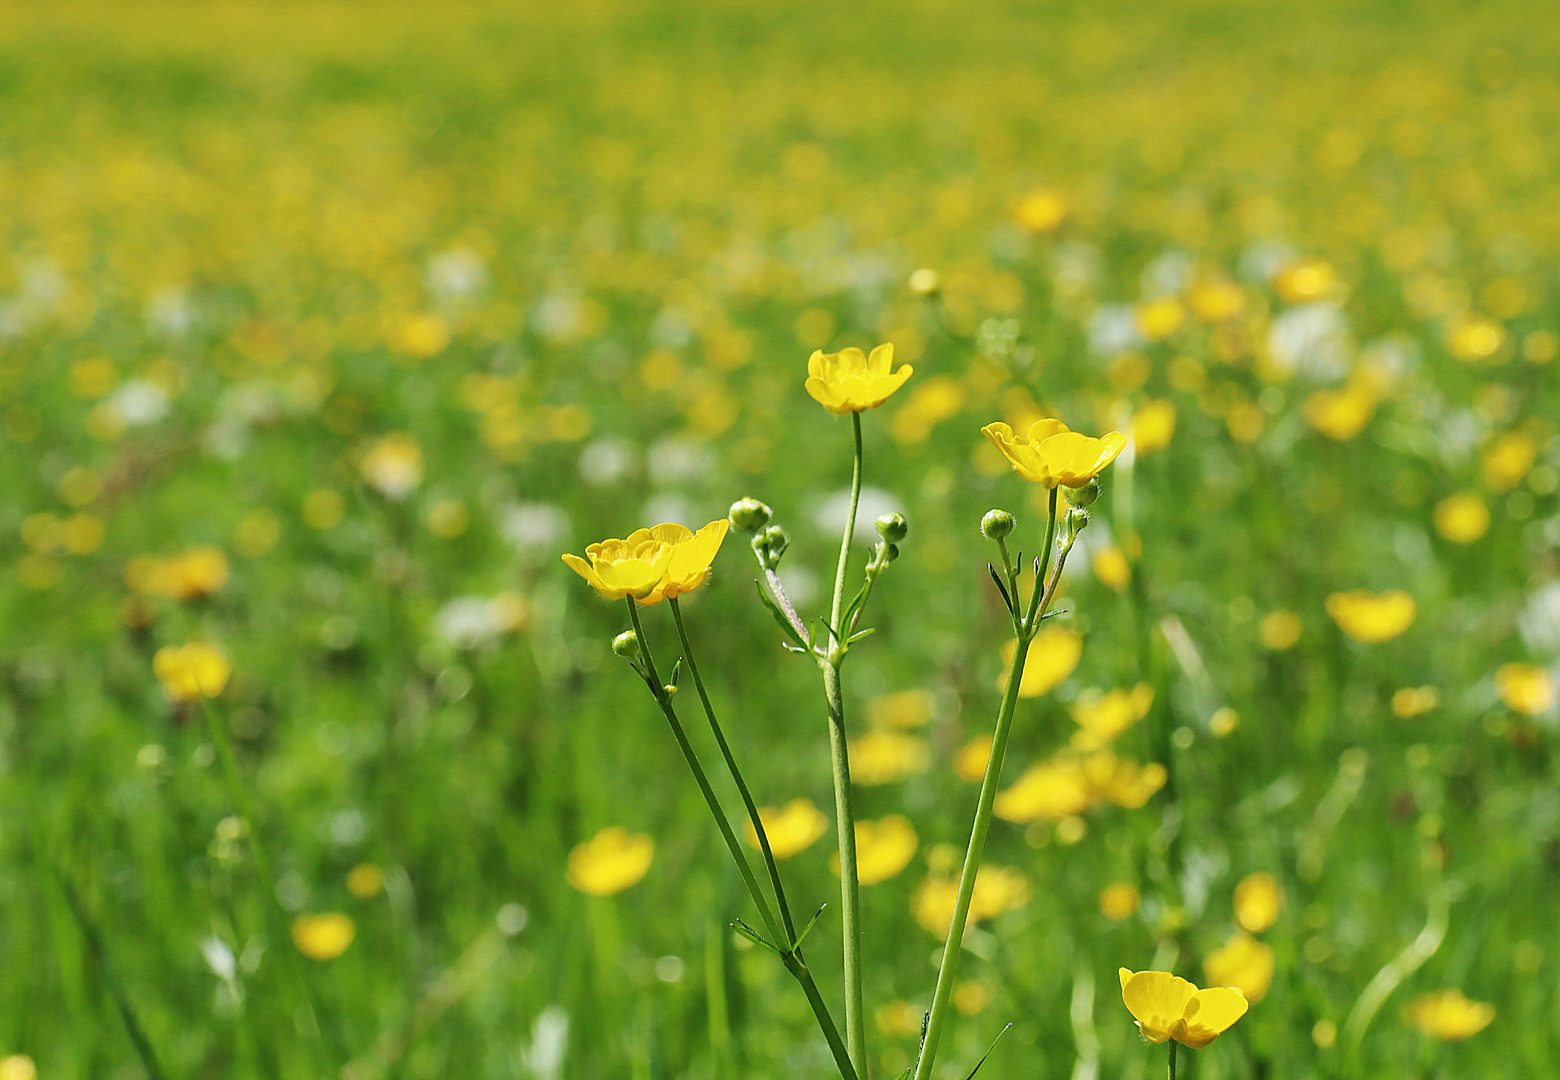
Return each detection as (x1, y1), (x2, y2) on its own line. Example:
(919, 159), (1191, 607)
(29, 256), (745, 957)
(822, 412), (867, 1077)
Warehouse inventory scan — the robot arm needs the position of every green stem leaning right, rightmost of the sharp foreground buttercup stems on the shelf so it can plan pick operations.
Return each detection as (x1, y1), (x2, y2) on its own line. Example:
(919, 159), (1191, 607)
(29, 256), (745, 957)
(916, 488), (1065, 1080)
